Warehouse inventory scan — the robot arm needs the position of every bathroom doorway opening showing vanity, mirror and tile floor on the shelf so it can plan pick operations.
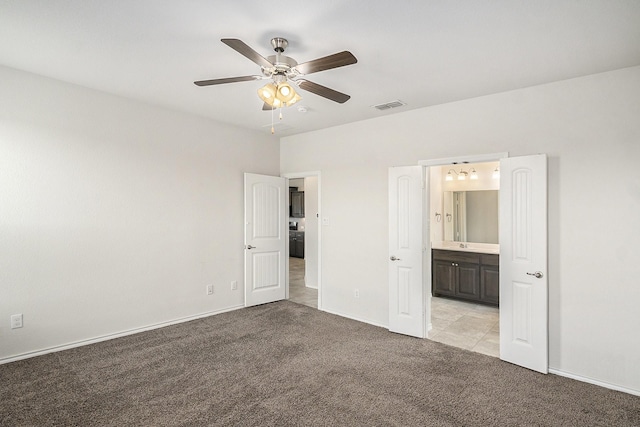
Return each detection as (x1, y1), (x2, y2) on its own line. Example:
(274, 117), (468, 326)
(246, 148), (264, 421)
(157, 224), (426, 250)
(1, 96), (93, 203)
(425, 161), (500, 357)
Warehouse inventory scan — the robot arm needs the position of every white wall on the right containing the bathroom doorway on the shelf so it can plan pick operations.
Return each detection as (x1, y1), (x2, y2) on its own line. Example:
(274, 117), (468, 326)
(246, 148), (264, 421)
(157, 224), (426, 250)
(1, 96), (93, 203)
(280, 67), (640, 392)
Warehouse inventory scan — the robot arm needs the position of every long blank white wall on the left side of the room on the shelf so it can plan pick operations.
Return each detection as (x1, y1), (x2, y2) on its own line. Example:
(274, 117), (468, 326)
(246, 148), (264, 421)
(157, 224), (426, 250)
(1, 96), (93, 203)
(0, 68), (279, 361)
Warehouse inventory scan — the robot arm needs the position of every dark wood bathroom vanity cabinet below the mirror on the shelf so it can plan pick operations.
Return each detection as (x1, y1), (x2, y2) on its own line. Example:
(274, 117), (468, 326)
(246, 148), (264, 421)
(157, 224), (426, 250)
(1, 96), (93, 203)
(431, 249), (500, 305)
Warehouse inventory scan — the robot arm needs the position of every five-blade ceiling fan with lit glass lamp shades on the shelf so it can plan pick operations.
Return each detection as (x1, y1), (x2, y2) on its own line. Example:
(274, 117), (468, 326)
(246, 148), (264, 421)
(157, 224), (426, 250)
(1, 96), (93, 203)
(194, 37), (358, 110)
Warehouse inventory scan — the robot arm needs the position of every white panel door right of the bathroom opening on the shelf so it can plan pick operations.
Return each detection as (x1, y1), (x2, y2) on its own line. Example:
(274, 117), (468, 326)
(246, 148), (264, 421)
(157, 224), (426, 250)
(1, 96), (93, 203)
(500, 154), (548, 374)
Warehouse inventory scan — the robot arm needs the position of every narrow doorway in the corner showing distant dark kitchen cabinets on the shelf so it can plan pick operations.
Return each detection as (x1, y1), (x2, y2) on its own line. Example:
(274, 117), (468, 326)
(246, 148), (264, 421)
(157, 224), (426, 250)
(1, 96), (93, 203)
(283, 172), (321, 309)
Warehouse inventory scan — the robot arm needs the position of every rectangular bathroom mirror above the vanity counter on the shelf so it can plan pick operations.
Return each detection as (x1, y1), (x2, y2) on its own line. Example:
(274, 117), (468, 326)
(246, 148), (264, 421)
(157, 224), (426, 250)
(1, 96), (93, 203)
(443, 190), (499, 243)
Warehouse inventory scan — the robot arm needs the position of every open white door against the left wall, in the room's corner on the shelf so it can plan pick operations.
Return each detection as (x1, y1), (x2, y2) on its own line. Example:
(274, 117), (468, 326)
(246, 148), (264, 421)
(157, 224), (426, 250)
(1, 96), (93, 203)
(244, 173), (289, 307)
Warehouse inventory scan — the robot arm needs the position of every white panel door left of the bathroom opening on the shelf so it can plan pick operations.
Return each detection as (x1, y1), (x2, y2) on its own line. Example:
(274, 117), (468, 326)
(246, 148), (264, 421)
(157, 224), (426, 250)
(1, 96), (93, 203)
(388, 166), (426, 338)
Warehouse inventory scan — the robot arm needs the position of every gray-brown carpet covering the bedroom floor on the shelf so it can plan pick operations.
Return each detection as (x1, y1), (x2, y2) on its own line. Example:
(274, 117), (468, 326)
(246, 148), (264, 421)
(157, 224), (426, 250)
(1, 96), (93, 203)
(0, 301), (640, 426)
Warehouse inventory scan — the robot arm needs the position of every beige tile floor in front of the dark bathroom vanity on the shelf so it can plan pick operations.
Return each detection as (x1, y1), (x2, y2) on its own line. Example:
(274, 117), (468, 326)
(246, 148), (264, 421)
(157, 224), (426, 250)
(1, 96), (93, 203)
(429, 297), (500, 357)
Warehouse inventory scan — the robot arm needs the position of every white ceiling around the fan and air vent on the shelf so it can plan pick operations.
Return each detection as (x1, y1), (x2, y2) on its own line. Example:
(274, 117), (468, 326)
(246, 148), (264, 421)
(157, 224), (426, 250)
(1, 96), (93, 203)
(0, 0), (640, 136)
